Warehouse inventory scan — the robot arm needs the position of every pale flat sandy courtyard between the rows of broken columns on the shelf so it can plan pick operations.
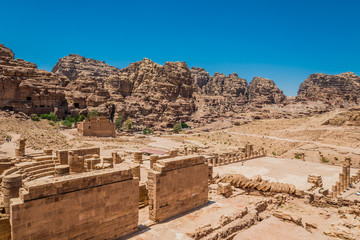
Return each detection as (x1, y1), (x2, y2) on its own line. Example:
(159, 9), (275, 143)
(214, 157), (360, 192)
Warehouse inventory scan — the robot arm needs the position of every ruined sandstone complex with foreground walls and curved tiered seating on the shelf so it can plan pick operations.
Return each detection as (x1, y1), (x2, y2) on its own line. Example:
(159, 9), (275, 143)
(0, 141), (272, 240)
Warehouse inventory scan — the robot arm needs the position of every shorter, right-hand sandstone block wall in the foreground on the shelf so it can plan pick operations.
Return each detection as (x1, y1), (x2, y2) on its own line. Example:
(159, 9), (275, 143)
(148, 155), (209, 222)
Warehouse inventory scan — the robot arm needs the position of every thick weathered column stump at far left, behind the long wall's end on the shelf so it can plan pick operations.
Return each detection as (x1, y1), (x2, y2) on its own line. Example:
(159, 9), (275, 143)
(1, 174), (22, 214)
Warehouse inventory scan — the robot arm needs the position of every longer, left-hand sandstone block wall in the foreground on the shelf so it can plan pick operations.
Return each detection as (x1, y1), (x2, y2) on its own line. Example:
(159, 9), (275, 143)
(10, 168), (139, 240)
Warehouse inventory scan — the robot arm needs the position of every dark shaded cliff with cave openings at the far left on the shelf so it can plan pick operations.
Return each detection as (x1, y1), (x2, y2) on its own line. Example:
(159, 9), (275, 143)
(0, 44), (68, 116)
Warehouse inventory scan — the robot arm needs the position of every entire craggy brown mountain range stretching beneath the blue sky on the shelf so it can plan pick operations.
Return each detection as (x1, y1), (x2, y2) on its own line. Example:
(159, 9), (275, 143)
(0, 42), (360, 129)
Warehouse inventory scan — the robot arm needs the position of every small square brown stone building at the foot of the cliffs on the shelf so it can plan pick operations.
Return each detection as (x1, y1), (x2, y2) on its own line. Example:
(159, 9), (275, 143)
(78, 117), (115, 137)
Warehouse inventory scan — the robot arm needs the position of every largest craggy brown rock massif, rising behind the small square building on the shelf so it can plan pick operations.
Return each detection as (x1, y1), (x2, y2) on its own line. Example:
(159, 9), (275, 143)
(53, 54), (195, 127)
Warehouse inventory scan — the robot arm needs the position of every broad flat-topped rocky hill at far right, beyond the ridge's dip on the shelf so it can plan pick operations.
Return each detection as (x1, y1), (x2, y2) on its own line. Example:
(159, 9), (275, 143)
(296, 72), (360, 105)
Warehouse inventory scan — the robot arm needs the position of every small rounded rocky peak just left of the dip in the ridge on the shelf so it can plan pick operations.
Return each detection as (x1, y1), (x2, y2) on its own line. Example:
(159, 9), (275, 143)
(248, 77), (286, 104)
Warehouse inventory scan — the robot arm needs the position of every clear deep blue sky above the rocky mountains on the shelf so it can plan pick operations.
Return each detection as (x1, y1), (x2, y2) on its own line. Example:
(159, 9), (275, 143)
(0, 0), (360, 96)
